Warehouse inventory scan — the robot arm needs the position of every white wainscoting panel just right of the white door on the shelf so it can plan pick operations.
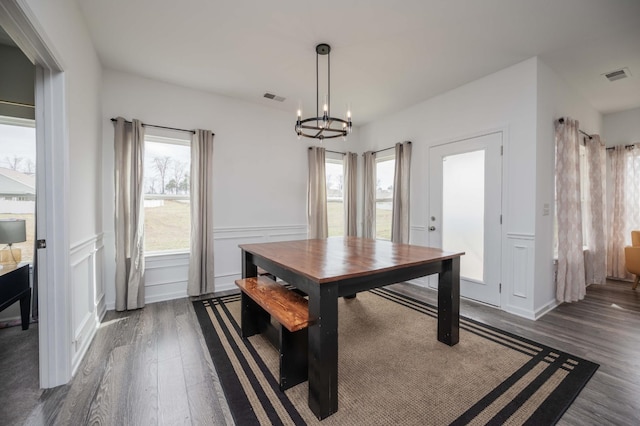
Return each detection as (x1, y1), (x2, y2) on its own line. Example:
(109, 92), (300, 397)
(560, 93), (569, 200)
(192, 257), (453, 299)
(502, 233), (535, 319)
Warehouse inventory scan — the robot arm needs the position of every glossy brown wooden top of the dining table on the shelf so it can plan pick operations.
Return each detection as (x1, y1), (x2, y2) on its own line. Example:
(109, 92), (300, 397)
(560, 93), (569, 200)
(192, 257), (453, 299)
(240, 237), (464, 283)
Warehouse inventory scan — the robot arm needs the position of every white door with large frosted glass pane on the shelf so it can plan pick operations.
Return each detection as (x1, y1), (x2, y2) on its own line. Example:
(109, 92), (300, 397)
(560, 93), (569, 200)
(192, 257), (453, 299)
(428, 132), (502, 306)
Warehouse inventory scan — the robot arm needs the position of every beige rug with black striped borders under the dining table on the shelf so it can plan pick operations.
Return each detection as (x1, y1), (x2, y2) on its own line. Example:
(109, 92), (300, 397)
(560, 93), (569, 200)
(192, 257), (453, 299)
(194, 288), (598, 426)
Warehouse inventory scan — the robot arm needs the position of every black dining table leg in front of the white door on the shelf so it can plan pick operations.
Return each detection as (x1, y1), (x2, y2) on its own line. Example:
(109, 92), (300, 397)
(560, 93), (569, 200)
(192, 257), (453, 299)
(438, 257), (460, 346)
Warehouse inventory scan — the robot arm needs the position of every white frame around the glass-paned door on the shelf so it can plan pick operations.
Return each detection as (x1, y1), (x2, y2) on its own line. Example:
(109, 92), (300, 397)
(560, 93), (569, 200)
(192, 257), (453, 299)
(424, 124), (509, 309)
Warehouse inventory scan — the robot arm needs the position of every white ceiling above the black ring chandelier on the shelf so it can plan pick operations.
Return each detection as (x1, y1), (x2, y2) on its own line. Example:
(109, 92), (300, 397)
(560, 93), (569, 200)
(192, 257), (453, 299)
(67, 0), (640, 125)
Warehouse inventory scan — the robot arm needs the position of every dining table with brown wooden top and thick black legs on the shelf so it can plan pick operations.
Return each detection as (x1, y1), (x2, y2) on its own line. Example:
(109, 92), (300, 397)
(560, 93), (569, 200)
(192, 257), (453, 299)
(240, 237), (464, 419)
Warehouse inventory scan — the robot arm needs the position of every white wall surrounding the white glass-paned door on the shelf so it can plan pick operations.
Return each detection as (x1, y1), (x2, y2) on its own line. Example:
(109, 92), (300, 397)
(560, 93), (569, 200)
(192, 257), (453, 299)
(359, 58), (537, 317)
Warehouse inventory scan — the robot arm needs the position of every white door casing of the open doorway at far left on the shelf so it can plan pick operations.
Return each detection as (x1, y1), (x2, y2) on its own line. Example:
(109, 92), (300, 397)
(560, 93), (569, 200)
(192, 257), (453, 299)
(0, 0), (72, 388)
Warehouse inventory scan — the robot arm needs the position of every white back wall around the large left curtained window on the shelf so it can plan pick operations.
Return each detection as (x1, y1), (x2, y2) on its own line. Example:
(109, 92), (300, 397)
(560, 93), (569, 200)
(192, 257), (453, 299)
(102, 70), (357, 308)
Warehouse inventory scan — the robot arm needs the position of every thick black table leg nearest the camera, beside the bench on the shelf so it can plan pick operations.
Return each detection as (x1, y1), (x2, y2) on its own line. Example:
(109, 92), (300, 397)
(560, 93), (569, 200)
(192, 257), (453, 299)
(309, 284), (338, 420)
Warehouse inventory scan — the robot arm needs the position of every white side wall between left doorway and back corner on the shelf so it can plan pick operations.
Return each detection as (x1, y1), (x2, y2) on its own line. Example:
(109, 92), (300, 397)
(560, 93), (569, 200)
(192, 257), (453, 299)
(24, 0), (104, 371)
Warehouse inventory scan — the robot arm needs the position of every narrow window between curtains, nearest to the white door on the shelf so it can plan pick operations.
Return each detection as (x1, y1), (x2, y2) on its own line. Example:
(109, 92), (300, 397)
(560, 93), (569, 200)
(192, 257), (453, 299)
(376, 154), (396, 240)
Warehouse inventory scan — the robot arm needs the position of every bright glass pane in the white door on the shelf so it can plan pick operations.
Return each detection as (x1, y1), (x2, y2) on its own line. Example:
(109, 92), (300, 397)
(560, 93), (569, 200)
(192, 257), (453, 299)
(442, 151), (484, 281)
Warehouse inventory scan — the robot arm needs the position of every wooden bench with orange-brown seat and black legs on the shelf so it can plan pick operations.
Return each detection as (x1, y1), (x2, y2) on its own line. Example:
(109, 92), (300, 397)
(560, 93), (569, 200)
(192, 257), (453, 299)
(236, 275), (309, 391)
